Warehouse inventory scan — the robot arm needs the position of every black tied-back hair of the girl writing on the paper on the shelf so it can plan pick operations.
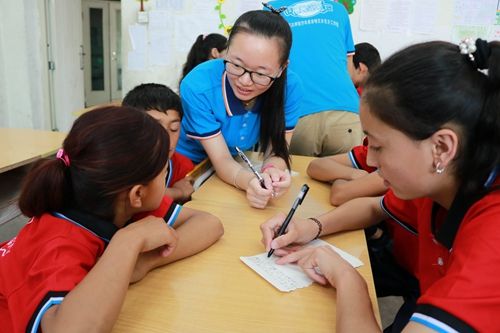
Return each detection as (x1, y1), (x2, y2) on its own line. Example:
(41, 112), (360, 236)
(362, 40), (500, 197)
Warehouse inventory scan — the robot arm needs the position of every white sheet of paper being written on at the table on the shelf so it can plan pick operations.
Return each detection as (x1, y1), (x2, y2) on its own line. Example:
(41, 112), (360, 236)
(240, 239), (363, 292)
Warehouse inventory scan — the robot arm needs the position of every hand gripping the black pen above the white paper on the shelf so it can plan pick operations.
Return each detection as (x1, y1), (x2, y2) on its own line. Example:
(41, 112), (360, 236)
(260, 213), (318, 256)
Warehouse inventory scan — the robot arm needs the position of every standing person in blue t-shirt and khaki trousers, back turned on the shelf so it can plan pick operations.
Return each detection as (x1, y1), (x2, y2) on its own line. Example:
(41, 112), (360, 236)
(269, 0), (363, 156)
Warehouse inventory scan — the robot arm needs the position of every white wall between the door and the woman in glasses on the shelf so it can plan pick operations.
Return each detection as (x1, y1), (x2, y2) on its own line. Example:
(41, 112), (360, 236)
(121, 0), (262, 94)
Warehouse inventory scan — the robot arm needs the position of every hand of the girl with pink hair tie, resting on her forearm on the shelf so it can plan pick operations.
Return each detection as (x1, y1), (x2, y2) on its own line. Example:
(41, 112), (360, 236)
(122, 215), (178, 257)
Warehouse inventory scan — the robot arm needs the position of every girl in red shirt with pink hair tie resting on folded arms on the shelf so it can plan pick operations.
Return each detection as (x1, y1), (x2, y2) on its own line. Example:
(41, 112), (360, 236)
(0, 107), (222, 332)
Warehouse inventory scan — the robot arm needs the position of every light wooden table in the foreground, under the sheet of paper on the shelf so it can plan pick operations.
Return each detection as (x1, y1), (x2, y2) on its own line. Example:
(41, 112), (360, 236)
(113, 157), (380, 333)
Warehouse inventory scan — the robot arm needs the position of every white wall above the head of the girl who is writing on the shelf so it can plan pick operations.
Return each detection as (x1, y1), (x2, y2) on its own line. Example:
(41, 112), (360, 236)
(350, 0), (500, 59)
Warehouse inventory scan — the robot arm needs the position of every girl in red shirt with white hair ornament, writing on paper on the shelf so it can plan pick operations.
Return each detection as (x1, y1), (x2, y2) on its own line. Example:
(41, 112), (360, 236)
(262, 39), (500, 332)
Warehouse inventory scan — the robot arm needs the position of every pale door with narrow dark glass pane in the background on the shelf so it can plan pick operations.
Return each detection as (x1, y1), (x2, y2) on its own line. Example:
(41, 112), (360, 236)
(82, 0), (121, 107)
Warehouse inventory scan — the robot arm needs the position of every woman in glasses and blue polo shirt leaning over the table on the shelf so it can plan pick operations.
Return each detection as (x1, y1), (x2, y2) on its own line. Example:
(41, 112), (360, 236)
(177, 10), (302, 208)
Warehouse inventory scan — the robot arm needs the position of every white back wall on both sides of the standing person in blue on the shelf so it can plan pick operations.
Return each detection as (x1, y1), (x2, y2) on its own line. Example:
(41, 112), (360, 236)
(122, 0), (500, 93)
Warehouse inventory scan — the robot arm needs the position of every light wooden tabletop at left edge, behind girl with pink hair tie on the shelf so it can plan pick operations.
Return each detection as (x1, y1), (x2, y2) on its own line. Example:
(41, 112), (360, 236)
(0, 128), (66, 173)
